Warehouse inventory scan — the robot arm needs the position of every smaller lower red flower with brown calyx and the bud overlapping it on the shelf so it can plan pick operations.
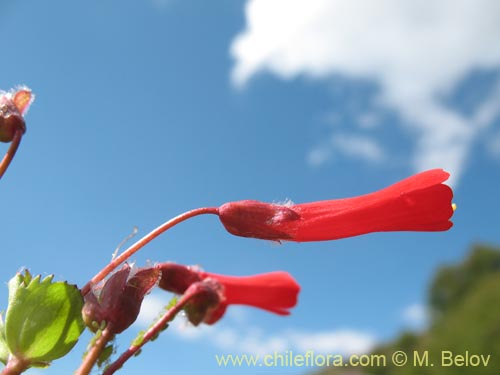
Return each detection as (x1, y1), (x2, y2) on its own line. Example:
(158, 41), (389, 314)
(156, 263), (300, 324)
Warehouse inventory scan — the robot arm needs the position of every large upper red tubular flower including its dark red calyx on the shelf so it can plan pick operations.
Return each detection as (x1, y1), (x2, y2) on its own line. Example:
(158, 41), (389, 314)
(219, 169), (453, 242)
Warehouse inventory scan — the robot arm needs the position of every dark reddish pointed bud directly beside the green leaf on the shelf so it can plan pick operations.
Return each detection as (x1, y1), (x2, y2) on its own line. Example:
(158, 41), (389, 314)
(82, 264), (160, 333)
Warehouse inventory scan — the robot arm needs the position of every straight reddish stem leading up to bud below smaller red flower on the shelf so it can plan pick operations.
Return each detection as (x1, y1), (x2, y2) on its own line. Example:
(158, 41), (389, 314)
(102, 289), (199, 375)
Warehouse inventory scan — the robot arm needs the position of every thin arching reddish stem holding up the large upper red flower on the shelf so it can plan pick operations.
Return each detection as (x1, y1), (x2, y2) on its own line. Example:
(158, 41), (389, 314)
(82, 207), (219, 295)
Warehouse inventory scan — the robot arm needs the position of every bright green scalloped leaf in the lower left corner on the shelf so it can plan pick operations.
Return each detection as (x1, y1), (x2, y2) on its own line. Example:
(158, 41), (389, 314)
(5, 271), (84, 366)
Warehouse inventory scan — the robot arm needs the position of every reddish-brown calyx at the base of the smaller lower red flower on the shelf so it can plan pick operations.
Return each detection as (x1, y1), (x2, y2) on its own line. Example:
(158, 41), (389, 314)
(155, 262), (201, 294)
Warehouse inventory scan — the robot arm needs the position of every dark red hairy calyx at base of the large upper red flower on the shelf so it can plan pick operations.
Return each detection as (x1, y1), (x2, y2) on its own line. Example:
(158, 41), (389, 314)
(219, 200), (300, 241)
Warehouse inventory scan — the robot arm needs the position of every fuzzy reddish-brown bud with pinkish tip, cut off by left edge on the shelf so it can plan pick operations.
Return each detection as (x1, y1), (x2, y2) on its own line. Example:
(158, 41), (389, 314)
(0, 87), (34, 142)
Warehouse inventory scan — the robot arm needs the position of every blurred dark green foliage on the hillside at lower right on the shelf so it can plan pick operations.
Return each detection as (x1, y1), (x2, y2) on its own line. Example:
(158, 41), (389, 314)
(319, 245), (500, 375)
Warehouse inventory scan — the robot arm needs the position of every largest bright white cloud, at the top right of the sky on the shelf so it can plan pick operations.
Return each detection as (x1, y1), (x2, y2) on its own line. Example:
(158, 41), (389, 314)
(231, 0), (500, 185)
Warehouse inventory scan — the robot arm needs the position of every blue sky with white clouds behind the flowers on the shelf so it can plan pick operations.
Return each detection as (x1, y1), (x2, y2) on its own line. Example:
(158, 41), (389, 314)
(0, 0), (500, 374)
